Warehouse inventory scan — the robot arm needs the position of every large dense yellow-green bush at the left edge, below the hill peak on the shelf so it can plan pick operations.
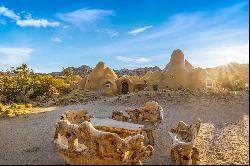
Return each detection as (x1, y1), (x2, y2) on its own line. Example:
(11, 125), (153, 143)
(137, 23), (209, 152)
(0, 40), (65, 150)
(0, 64), (71, 103)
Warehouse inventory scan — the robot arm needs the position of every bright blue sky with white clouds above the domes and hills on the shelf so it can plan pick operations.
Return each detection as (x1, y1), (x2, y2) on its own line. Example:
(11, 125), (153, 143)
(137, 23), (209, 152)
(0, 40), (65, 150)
(0, 0), (249, 72)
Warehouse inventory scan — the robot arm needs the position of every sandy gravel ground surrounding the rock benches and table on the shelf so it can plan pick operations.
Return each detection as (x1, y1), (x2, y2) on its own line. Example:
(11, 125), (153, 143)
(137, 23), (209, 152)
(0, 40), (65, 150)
(0, 92), (249, 164)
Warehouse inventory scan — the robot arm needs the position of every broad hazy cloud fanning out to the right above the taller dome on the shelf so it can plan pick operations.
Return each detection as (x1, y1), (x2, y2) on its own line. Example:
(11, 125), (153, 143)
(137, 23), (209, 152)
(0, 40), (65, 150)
(83, 1), (249, 67)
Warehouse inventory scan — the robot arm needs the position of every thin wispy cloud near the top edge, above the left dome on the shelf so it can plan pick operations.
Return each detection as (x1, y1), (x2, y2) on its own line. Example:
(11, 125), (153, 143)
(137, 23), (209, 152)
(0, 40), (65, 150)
(58, 8), (114, 27)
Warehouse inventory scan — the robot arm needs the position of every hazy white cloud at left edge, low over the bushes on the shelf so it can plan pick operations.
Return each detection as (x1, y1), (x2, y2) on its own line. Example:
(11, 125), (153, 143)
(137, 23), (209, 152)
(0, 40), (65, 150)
(0, 46), (33, 67)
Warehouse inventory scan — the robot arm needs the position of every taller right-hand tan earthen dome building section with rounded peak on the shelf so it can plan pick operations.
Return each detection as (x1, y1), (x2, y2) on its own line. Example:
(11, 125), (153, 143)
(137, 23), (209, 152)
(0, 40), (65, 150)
(145, 49), (211, 89)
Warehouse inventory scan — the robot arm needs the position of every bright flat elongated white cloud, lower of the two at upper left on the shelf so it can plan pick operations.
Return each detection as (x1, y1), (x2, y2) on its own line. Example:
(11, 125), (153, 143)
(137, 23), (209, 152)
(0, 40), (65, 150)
(16, 18), (60, 27)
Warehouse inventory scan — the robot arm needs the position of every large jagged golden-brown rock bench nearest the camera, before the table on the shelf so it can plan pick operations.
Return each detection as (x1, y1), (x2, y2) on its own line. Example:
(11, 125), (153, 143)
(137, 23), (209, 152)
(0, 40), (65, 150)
(54, 110), (154, 165)
